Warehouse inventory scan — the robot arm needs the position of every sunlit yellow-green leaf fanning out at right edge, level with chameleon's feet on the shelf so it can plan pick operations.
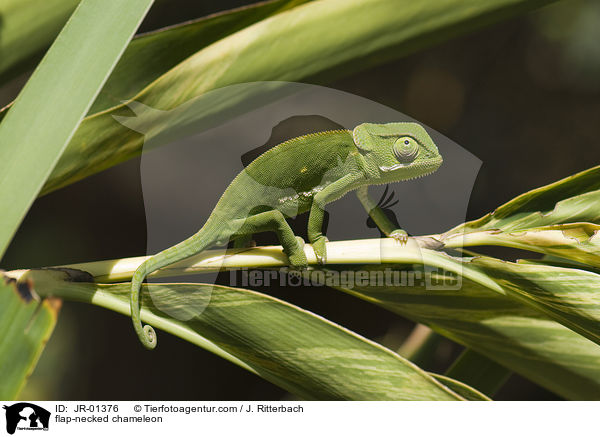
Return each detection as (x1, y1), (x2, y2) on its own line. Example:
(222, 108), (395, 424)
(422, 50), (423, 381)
(438, 166), (600, 267)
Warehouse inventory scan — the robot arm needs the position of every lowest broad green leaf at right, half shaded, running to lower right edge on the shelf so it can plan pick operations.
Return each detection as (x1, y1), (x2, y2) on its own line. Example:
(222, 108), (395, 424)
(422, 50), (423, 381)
(326, 264), (600, 400)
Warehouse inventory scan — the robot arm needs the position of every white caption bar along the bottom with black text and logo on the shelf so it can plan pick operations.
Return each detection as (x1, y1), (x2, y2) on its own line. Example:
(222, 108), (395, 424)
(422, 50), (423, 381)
(0, 401), (598, 437)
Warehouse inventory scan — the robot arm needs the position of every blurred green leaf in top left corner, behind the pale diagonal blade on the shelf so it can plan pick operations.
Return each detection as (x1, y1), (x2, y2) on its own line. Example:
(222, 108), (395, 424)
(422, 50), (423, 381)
(0, 0), (79, 82)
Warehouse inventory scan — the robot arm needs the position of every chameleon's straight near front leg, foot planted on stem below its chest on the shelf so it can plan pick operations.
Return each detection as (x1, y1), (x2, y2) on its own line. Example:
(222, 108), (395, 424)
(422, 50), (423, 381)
(308, 174), (360, 264)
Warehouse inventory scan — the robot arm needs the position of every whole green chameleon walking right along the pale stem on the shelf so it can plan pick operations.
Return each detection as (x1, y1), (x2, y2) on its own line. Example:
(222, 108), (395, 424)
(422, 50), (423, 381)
(130, 123), (442, 349)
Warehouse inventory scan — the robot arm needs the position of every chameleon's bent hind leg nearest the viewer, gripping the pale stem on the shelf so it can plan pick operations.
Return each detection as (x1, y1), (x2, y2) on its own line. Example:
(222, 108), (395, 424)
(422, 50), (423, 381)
(233, 209), (308, 268)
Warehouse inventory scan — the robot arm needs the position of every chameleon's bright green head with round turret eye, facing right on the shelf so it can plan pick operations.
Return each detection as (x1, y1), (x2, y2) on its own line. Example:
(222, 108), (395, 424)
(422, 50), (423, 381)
(352, 123), (443, 183)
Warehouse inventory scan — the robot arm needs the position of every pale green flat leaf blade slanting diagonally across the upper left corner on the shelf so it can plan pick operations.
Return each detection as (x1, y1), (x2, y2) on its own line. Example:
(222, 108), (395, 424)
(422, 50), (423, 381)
(0, 0), (152, 257)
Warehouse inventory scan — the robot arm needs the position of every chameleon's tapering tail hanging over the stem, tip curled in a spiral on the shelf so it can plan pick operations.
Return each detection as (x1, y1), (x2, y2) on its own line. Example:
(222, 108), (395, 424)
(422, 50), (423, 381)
(129, 227), (215, 349)
